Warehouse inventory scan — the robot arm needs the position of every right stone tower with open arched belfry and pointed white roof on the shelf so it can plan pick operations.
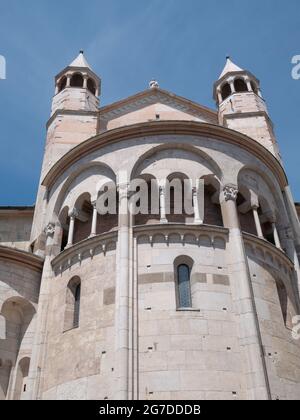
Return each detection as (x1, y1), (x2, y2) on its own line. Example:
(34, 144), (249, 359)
(214, 57), (280, 158)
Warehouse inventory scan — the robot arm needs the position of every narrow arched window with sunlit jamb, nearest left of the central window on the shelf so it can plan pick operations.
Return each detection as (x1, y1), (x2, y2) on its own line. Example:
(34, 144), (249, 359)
(64, 277), (81, 331)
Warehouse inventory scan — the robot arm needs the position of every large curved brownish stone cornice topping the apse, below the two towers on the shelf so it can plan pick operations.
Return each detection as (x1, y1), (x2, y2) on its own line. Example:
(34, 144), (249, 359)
(42, 121), (288, 189)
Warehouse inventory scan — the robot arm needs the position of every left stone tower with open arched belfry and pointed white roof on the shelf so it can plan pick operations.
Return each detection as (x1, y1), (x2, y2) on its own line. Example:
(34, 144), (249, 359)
(31, 51), (101, 250)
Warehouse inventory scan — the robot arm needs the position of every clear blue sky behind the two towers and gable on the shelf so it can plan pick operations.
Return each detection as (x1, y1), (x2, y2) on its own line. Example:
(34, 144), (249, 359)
(0, 0), (300, 205)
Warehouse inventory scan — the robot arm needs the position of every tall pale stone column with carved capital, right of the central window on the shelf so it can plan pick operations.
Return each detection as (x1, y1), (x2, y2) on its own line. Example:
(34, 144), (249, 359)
(220, 185), (271, 400)
